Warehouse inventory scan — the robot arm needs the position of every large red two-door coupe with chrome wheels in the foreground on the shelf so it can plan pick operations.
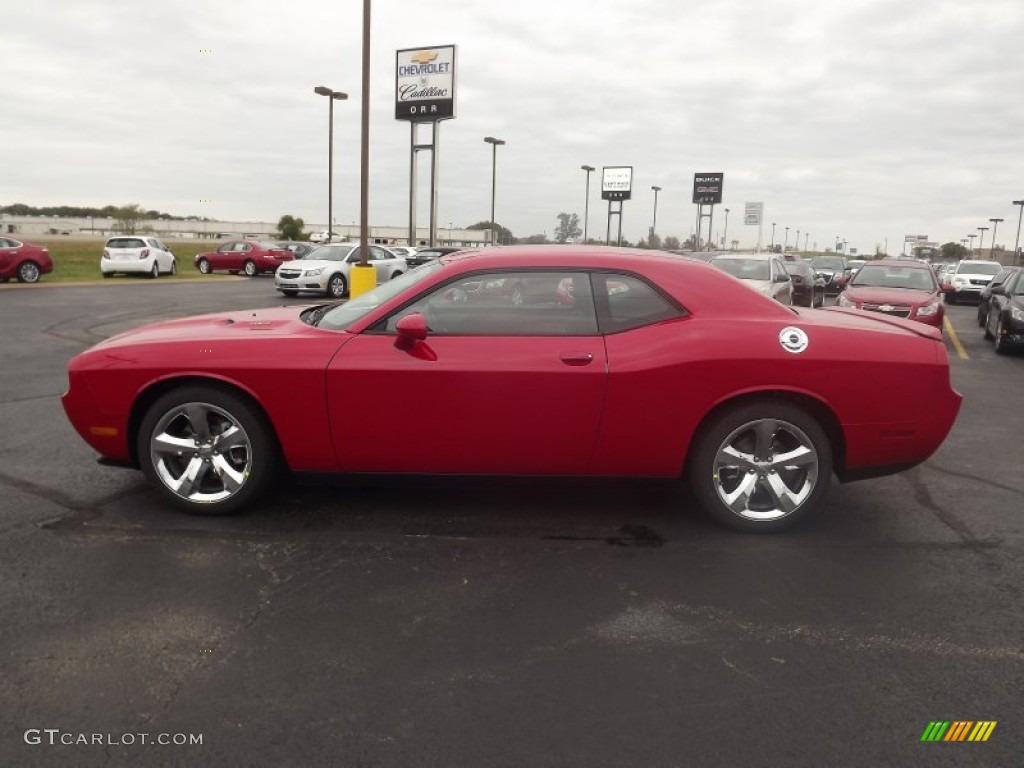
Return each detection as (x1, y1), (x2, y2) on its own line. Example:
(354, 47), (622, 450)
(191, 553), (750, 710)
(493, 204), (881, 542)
(63, 246), (961, 531)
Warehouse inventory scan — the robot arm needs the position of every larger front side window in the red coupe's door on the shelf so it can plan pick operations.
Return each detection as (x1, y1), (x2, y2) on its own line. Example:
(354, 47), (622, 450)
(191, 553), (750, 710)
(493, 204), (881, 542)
(375, 271), (598, 336)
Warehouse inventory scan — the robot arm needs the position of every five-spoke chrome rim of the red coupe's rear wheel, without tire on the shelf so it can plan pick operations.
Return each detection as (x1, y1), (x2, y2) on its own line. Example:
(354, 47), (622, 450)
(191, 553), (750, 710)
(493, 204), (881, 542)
(714, 419), (819, 520)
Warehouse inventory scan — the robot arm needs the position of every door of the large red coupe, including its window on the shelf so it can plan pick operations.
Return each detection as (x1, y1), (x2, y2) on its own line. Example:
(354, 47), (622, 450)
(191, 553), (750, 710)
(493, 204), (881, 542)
(328, 271), (607, 474)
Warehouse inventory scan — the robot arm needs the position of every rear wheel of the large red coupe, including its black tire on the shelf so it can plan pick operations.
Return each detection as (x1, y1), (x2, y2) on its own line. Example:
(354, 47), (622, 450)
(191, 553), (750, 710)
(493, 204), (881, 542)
(687, 399), (833, 534)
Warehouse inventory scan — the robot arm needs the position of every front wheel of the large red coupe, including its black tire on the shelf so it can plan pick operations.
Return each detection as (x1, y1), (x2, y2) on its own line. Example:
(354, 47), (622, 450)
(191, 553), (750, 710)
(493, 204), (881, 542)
(135, 384), (282, 516)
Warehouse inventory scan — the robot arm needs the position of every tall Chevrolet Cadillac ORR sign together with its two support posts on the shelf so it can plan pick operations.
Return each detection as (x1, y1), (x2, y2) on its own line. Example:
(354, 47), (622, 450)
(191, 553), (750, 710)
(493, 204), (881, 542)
(394, 45), (457, 246)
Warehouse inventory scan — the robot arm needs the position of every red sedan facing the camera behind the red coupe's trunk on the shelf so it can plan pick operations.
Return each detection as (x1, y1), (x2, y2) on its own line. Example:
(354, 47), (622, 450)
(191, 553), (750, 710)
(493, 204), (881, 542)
(839, 259), (945, 329)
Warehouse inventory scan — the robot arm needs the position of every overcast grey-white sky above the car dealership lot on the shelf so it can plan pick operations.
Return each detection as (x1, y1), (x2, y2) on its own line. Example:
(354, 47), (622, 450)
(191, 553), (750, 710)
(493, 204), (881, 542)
(0, 0), (1024, 252)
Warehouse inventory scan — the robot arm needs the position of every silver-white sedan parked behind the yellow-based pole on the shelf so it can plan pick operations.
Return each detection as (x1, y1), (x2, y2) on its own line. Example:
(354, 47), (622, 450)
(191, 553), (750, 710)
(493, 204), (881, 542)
(273, 243), (409, 299)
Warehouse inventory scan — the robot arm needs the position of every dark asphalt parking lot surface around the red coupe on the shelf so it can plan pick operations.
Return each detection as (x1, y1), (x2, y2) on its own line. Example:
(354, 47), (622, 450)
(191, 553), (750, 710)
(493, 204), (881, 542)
(0, 278), (1024, 767)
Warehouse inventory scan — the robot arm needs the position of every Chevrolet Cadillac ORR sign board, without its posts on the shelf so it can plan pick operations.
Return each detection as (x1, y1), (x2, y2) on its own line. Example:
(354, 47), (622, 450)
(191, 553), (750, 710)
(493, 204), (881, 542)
(394, 45), (456, 122)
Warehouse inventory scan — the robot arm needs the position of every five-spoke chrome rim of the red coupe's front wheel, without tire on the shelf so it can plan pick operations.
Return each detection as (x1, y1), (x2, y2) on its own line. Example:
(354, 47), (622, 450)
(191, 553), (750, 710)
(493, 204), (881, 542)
(150, 402), (253, 504)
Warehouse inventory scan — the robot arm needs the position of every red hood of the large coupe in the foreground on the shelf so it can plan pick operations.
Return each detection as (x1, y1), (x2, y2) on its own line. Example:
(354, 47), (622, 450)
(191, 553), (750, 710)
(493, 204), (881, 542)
(92, 306), (323, 351)
